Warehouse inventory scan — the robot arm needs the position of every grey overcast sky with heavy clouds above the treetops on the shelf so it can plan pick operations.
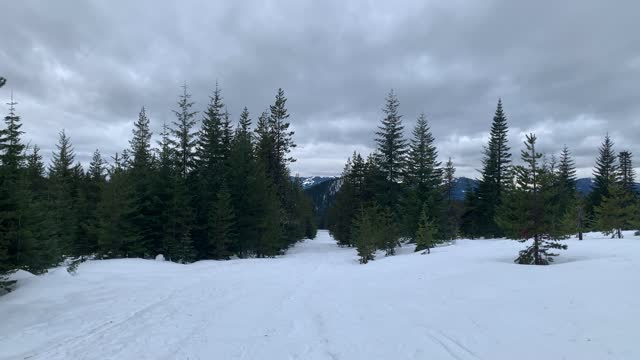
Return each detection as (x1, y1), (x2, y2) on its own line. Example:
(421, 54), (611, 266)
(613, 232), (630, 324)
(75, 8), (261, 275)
(0, 0), (640, 177)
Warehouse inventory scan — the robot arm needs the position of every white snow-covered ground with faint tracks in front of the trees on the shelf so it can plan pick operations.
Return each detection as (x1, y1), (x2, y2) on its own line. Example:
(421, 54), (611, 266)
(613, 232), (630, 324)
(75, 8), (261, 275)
(0, 232), (640, 360)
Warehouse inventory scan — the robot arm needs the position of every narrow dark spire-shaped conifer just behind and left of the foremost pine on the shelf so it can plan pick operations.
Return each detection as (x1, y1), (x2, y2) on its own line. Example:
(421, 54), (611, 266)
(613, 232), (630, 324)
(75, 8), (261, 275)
(477, 99), (512, 237)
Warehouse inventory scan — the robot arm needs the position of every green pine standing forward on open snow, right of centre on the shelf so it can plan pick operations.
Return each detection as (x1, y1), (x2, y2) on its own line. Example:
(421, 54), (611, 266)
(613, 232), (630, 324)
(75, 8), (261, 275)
(496, 134), (567, 265)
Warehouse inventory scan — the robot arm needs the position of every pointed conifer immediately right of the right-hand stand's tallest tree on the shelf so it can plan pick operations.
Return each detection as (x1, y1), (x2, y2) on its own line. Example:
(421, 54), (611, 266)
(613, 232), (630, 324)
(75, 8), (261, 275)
(403, 113), (446, 242)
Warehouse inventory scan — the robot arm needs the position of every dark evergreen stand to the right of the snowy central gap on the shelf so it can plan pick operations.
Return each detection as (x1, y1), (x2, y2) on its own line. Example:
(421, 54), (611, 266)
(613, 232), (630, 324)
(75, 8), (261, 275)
(327, 91), (640, 265)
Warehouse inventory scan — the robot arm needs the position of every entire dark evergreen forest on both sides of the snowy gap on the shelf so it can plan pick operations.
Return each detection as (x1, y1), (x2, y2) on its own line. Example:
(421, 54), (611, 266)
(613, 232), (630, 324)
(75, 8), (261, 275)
(0, 72), (640, 289)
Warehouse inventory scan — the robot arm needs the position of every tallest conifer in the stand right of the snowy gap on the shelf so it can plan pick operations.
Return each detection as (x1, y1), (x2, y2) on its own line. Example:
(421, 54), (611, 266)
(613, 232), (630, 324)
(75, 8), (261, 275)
(375, 90), (407, 213)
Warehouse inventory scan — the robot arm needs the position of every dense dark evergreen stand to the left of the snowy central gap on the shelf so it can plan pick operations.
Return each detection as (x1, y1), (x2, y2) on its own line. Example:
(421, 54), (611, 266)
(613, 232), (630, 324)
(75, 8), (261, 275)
(0, 79), (316, 287)
